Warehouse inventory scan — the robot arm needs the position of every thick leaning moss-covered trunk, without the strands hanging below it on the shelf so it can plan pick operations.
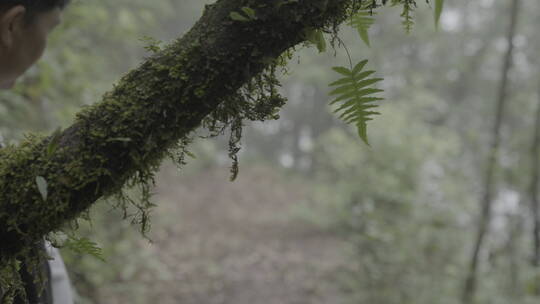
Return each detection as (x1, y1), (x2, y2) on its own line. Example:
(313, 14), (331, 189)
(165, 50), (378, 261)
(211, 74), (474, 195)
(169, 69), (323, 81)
(0, 0), (354, 262)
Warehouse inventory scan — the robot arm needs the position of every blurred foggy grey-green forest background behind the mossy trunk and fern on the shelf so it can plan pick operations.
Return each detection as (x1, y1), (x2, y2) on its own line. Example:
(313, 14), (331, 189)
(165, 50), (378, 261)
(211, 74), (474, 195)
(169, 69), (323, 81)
(0, 0), (540, 304)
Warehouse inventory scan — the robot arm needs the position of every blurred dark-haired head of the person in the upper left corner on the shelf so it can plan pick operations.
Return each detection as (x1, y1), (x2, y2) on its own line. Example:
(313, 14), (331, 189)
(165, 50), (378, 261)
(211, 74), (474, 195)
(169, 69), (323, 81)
(0, 0), (70, 89)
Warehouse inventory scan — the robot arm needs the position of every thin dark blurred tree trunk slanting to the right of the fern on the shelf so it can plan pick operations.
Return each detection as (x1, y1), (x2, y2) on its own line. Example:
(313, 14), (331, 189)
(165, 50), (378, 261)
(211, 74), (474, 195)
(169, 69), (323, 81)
(462, 0), (520, 304)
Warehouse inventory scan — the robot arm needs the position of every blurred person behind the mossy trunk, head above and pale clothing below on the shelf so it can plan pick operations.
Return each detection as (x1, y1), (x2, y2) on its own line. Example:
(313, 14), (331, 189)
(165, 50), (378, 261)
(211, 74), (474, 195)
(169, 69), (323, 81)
(0, 0), (73, 304)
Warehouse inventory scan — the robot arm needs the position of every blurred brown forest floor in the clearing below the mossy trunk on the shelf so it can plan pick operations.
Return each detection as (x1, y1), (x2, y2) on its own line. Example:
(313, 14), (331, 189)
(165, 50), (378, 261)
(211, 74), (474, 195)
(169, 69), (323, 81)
(147, 166), (346, 304)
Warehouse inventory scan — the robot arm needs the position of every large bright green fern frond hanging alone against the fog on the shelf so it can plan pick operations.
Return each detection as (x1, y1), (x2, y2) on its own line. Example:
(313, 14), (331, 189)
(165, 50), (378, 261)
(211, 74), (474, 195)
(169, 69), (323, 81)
(330, 60), (383, 146)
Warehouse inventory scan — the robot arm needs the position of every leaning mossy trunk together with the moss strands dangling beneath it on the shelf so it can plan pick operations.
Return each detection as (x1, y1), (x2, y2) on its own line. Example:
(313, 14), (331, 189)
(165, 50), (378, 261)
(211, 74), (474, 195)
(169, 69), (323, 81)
(0, 0), (438, 304)
